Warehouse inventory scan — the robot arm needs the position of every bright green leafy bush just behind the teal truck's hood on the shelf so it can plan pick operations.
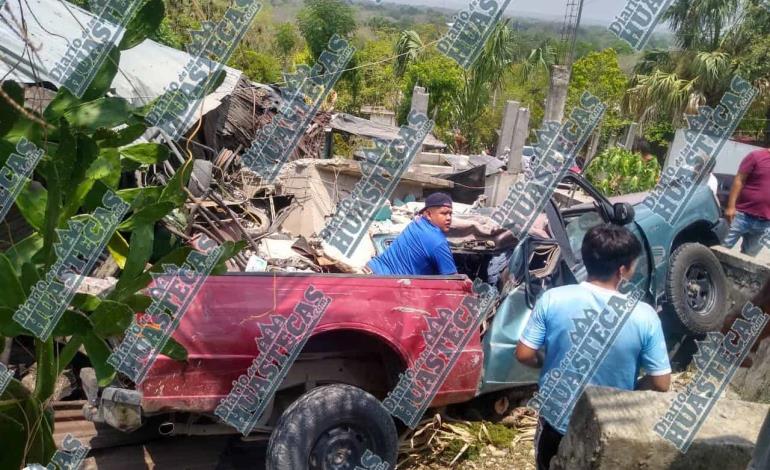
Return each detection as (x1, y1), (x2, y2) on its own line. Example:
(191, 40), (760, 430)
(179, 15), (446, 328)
(585, 147), (660, 196)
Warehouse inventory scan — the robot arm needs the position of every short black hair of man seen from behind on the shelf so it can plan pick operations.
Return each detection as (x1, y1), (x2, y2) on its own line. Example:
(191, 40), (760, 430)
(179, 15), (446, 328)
(580, 224), (642, 281)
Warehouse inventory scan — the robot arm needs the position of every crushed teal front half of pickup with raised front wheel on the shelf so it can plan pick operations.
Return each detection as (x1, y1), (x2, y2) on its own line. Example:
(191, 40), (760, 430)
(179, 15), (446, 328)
(472, 173), (728, 393)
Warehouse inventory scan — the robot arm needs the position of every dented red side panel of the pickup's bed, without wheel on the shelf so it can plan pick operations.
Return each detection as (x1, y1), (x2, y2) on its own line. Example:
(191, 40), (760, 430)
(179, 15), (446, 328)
(139, 273), (483, 413)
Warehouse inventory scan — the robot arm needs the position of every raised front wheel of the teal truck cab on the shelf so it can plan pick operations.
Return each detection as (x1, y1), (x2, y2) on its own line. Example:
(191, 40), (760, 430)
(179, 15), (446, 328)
(666, 243), (727, 333)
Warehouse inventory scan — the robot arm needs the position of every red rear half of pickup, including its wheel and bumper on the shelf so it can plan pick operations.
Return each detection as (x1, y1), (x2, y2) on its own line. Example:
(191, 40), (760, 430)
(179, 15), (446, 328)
(86, 273), (492, 469)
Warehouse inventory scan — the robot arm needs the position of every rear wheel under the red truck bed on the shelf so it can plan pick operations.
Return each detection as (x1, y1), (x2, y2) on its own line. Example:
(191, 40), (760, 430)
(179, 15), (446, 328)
(267, 384), (398, 470)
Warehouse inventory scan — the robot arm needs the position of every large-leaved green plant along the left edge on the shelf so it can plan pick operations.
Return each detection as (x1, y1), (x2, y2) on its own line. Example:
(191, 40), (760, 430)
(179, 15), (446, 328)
(0, 5), (243, 468)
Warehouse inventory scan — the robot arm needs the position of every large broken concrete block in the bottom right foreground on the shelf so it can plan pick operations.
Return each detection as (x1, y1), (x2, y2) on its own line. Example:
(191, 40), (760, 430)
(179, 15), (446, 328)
(551, 387), (769, 470)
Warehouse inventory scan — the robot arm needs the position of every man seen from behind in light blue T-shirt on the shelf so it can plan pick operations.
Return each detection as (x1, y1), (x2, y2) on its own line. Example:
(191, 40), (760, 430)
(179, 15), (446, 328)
(516, 224), (671, 470)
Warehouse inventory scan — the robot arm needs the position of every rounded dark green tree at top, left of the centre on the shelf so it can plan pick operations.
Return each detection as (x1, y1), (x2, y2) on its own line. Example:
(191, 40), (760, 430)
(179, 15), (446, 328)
(297, 0), (356, 60)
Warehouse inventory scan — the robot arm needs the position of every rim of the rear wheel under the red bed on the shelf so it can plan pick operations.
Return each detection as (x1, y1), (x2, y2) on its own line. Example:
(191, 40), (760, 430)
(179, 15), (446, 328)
(308, 425), (371, 470)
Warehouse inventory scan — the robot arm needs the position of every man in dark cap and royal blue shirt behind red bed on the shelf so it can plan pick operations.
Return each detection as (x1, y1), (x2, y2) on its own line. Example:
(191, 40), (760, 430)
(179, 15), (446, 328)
(367, 193), (457, 276)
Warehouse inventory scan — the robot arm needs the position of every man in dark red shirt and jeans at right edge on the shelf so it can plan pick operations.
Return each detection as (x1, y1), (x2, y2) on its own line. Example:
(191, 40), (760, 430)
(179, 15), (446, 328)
(725, 149), (770, 256)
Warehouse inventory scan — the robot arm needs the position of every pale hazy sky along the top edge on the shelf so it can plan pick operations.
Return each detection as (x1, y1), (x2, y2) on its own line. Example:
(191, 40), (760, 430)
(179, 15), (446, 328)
(386, 0), (626, 26)
